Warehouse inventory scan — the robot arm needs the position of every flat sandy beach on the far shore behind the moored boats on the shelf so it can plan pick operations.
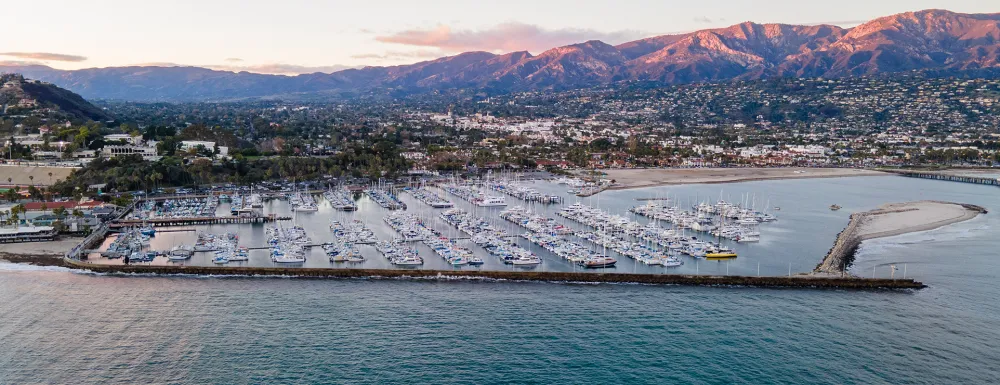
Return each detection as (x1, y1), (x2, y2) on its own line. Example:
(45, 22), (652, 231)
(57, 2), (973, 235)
(603, 167), (891, 190)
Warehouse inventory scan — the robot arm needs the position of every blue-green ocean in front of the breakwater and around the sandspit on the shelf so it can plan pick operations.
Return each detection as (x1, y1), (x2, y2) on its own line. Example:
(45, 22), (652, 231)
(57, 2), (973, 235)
(0, 177), (1000, 384)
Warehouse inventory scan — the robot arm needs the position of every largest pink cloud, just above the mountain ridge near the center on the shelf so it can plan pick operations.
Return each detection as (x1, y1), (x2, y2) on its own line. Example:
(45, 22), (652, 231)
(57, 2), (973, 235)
(375, 22), (649, 53)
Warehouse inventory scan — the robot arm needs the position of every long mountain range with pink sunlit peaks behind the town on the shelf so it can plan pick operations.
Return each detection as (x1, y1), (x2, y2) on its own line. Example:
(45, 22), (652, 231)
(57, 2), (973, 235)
(0, 10), (1000, 101)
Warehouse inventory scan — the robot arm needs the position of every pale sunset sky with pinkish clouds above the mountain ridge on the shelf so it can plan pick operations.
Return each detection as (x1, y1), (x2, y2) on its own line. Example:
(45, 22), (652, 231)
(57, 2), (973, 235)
(0, 0), (1000, 75)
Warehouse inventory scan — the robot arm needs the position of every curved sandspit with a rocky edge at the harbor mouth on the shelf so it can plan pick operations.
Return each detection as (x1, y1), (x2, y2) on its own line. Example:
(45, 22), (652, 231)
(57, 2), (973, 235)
(810, 200), (987, 276)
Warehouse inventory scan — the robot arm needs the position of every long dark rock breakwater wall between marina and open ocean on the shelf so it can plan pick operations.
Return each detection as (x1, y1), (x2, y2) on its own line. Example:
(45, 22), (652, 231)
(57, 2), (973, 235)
(65, 259), (925, 290)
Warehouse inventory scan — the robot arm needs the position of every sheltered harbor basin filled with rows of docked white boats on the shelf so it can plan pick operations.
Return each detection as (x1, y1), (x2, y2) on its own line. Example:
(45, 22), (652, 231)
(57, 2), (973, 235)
(78, 176), (976, 276)
